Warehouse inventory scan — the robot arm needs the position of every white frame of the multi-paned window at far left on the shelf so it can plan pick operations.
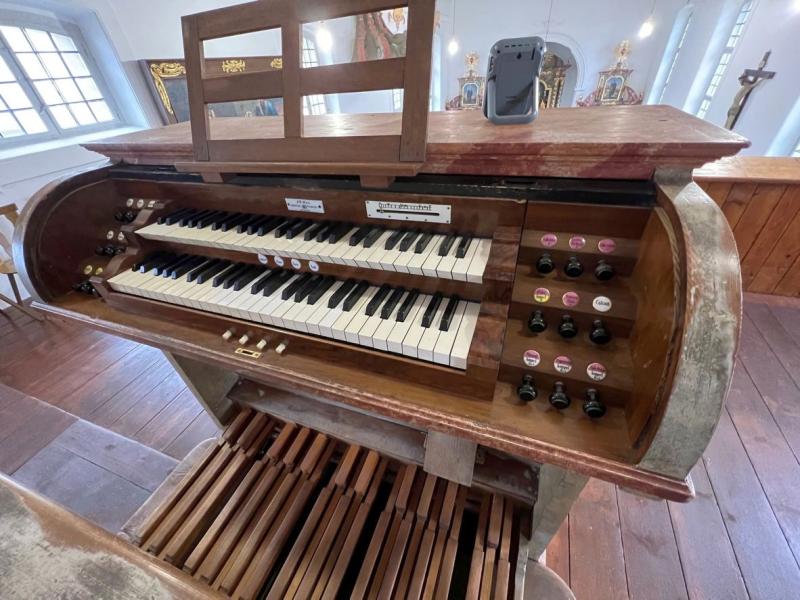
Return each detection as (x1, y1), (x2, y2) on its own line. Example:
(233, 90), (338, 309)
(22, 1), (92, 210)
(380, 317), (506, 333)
(0, 10), (125, 150)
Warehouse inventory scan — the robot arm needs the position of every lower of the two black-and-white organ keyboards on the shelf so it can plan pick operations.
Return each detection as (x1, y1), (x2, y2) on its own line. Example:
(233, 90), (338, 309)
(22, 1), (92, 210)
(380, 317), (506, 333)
(108, 252), (480, 370)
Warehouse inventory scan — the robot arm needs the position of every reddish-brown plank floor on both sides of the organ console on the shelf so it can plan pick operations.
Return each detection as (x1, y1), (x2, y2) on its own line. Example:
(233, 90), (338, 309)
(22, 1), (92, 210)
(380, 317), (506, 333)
(0, 295), (800, 600)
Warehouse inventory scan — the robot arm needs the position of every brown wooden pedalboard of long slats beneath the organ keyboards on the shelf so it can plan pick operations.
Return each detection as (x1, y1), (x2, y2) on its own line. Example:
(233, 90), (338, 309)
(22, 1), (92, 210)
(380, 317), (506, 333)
(130, 409), (531, 600)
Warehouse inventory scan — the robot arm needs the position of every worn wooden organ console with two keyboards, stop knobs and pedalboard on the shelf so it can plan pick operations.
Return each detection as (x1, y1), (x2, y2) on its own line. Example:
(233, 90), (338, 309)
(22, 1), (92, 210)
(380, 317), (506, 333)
(7, 2), (747, 598)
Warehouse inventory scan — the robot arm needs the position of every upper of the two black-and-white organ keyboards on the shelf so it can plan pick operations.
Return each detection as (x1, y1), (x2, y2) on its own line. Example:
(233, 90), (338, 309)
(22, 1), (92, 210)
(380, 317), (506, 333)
(136, 209), (492, 283)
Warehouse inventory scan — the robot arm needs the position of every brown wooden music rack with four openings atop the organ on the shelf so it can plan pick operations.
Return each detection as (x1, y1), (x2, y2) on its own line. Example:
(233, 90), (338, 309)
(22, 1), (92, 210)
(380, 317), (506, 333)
(178, 0), (435, 187)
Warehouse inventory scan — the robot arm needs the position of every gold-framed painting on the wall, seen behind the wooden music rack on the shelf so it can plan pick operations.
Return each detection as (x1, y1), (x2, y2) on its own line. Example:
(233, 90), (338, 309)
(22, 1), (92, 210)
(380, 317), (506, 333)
(140, 56), (283, 125)
